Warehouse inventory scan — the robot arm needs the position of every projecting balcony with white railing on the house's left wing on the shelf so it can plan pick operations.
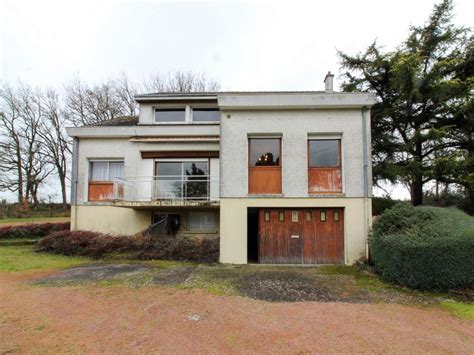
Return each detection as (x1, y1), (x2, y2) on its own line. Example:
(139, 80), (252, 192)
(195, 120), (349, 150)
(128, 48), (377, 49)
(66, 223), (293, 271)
(113, 175), (219, 208)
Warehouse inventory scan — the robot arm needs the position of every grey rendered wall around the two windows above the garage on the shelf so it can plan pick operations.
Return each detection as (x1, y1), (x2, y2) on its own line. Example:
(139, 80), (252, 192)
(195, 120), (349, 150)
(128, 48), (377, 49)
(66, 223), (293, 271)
(220, 109), (371, 198)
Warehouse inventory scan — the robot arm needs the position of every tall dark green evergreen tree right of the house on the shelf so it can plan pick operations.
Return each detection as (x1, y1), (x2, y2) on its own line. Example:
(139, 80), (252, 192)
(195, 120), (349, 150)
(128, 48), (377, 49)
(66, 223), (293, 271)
(339, 0), (474, 205)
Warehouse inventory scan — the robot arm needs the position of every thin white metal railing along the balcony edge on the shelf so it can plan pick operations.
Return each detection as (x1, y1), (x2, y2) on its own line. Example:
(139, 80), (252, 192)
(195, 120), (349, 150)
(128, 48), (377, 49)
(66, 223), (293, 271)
(114, 175), (219, 201)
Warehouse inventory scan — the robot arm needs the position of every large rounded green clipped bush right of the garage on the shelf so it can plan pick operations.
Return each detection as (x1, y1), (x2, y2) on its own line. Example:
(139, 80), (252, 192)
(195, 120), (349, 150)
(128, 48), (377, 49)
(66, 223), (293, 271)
(369, 203), (474, 291)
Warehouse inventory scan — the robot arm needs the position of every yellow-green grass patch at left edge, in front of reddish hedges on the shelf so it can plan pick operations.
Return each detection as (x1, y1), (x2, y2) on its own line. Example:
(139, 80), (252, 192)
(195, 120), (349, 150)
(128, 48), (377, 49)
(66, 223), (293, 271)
(0, 245), (90, 271)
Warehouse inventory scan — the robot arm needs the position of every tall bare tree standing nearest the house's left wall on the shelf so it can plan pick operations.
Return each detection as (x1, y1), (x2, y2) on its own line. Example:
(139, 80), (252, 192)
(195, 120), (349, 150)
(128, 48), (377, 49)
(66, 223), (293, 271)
(39, 89), (72, 209)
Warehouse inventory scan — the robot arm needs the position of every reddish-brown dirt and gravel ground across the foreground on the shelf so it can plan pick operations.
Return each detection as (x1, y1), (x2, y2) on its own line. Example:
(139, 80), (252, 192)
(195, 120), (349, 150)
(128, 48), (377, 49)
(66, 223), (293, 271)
(0, 267), (474, 354)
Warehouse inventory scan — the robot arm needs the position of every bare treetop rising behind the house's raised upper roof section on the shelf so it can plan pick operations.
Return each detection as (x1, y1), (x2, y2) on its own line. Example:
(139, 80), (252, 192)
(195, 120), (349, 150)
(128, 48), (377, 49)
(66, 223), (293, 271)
(143, 71), (220, 92)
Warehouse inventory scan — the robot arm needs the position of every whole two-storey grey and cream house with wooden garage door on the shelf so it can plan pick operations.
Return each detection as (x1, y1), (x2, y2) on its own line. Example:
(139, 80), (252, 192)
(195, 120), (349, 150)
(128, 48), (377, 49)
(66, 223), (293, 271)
(68, 73), (374, 264)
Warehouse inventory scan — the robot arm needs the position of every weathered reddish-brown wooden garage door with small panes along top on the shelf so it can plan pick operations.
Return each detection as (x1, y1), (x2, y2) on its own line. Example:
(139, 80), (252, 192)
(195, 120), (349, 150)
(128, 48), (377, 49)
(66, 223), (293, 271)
(258, 208), (344, 264)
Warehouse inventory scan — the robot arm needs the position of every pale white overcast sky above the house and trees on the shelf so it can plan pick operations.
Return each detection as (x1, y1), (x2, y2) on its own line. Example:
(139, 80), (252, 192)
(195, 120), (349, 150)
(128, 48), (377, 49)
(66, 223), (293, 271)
(0, 0), (474, 200)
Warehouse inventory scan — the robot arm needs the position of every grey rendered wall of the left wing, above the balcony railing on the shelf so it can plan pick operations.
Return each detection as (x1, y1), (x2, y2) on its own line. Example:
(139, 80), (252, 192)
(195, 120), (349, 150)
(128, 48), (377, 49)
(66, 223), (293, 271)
(77, 137), (219, 204)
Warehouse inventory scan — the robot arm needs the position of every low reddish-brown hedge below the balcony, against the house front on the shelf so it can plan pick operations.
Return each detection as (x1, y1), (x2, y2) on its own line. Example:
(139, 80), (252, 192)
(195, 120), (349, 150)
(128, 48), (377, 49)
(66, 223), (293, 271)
(36, 230), (219, 262)
